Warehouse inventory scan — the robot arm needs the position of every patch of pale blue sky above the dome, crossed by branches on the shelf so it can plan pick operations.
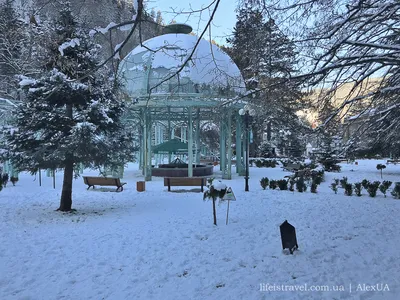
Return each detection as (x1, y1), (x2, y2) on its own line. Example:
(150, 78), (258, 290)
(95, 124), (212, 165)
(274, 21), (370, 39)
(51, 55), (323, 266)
(147, 0), (237, 44)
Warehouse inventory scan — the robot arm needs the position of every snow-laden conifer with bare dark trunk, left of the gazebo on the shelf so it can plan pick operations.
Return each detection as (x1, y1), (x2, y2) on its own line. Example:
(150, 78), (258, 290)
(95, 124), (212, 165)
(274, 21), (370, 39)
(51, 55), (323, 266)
(6, 5), (133, 211)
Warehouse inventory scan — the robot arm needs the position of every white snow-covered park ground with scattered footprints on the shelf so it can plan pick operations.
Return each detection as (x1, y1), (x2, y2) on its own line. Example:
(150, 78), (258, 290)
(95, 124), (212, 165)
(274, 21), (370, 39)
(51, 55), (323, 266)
(0, 160), (400, 300)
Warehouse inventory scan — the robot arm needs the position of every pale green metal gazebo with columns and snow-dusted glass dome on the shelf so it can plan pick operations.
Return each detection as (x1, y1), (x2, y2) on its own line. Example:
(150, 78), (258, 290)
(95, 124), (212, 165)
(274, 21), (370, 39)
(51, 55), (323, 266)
(119, 24), (246, 181)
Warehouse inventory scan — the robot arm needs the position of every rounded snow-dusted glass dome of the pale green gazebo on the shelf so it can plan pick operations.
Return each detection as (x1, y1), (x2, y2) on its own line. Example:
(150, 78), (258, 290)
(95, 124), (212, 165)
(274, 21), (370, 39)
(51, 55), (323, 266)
(119, 33), (245, 98)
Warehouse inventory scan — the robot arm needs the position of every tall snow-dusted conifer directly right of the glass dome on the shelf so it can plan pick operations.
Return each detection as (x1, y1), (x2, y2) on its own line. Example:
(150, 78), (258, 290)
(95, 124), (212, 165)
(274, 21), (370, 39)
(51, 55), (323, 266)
(226, 5), (307, 157)
